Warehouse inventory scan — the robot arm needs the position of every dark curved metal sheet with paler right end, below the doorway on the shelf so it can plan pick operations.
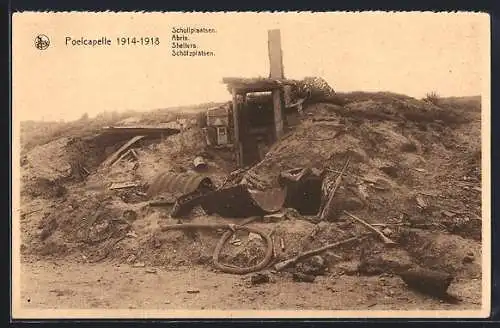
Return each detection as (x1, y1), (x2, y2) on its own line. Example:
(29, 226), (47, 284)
(201, 185), (285, 218)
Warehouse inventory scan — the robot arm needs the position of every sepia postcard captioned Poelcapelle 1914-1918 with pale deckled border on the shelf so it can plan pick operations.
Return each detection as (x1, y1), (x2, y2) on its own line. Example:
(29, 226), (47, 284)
(11, 12), (491, 319)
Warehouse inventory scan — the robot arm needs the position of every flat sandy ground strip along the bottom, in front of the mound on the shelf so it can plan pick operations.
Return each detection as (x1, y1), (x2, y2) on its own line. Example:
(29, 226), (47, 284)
(21, 261), (481, 310)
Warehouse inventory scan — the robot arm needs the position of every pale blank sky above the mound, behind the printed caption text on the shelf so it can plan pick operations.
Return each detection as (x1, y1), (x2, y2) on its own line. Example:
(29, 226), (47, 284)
(12, 12), (489, 121)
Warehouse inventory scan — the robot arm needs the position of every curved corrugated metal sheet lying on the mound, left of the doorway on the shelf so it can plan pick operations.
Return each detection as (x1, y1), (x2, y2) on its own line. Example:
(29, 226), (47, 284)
(147, 172), (215, 198)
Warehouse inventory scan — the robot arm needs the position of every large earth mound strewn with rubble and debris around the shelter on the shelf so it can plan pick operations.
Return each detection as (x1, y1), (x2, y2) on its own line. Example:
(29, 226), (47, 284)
(21, 91), (482, 302)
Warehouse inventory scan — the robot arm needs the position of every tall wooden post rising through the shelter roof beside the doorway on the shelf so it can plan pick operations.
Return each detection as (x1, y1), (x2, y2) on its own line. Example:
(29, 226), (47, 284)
(268, 30), (285, 139)
